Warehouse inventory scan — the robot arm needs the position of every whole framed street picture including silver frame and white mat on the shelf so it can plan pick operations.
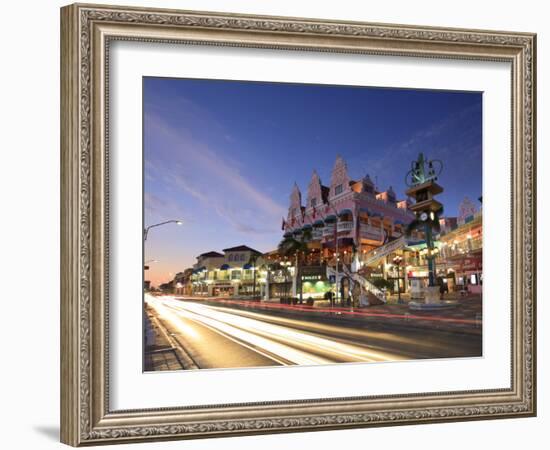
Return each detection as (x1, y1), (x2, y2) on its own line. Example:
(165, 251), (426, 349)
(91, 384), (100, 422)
(61, 4), (536, 446)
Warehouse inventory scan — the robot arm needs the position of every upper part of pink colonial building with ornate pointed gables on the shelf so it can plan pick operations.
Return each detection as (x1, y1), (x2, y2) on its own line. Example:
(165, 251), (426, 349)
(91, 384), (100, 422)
(283, 156), (415, 263)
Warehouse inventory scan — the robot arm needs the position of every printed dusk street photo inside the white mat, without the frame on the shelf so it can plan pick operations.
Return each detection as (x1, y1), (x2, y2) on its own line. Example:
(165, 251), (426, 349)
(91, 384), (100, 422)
(143, 77), (483, 371)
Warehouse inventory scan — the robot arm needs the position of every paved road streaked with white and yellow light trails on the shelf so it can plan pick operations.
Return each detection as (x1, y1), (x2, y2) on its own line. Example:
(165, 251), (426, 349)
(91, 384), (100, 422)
(146, 296), (481, 369)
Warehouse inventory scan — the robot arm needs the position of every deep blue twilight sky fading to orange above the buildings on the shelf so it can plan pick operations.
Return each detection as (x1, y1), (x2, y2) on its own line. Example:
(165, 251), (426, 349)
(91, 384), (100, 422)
(143, 77), (482, 285)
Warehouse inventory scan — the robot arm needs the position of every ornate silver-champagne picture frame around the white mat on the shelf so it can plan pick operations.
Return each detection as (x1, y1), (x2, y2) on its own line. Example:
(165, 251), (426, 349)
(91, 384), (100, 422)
(61, 4), (536, 446)
